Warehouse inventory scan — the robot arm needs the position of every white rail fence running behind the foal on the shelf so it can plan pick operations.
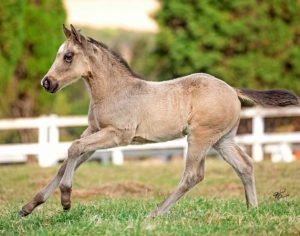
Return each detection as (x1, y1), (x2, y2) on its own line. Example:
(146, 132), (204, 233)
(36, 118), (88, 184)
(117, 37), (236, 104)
(0, 107), (300, 167)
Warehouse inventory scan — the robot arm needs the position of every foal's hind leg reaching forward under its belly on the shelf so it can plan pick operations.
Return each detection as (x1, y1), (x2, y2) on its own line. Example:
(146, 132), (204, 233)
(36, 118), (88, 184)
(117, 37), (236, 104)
(150, 133), (211, 217)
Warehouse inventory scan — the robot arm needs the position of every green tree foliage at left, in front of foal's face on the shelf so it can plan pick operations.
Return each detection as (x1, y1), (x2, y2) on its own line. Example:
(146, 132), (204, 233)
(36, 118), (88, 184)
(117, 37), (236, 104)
(0, 0), (66, 117)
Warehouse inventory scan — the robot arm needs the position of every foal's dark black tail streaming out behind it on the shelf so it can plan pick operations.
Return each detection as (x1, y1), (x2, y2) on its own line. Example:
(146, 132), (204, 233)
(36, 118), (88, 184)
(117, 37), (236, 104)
(236, 88), (300, 107)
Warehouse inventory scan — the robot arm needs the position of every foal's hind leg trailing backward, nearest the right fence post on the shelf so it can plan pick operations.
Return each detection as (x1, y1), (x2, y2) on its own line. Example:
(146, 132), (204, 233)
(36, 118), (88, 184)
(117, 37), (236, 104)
(214, 131), (257, 207)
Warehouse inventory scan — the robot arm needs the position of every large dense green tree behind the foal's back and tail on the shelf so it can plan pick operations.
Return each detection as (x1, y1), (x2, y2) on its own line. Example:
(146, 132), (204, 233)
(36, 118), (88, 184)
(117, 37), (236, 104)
(149, 0), (300, 93)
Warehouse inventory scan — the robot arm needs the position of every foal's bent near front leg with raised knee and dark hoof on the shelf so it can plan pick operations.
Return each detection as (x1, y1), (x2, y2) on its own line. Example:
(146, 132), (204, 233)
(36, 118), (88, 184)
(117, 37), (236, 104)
(59, 127), (127, 210)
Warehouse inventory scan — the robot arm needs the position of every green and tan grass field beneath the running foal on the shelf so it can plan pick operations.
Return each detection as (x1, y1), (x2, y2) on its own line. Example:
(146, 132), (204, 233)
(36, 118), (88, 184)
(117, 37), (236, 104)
(0, 159), (300, 235)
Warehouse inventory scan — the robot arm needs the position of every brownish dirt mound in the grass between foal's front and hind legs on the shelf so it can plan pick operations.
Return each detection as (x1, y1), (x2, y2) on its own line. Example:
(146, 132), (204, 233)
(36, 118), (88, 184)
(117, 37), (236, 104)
(72, 182), (160, 198)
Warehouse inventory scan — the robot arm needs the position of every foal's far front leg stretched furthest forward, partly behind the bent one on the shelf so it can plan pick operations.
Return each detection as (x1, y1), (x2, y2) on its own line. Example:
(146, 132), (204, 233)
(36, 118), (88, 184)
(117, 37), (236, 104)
(20, 152), (93, 216)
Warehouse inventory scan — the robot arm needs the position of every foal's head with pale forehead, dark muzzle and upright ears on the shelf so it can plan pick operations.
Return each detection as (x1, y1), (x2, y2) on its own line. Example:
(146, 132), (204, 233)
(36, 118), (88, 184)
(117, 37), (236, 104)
(41, 25), (89, 93)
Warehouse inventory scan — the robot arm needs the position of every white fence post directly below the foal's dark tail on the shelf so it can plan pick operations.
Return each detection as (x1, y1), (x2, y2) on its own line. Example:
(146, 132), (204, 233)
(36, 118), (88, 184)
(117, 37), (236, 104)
(252, 108), (264, 161)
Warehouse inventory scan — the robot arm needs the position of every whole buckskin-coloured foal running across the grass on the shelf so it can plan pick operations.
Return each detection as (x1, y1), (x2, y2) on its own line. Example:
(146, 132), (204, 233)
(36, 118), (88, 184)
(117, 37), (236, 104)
(20, 25), (299, 217)
